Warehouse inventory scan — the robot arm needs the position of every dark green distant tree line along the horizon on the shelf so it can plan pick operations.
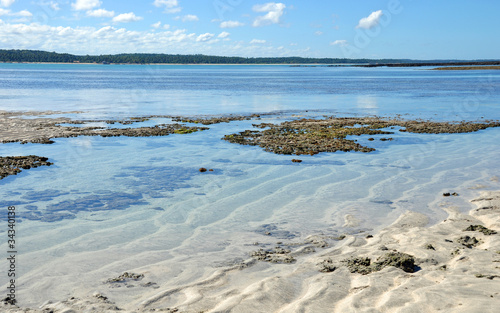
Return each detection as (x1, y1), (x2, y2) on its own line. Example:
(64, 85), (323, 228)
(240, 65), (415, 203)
(0, 50), (494, 66)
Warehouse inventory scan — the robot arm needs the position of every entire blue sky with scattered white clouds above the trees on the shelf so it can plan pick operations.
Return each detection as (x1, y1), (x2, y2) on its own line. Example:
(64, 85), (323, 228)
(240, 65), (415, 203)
(0, 0), (500, 60)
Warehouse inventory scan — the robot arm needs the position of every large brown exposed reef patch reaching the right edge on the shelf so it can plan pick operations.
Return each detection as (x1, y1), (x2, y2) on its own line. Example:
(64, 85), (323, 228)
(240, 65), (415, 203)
(223, 117), (500, 155)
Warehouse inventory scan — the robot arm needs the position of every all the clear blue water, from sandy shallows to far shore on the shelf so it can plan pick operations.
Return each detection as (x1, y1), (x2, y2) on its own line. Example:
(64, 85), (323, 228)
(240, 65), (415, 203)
(0, 64), (500, 306)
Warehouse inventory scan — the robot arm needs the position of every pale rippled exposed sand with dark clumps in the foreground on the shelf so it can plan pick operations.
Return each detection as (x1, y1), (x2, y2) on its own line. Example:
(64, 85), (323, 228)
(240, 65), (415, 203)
(1, 191), (500, 313)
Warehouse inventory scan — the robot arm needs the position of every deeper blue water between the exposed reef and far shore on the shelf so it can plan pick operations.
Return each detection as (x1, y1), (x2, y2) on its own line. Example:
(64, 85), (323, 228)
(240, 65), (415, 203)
(0, 64), (500, 119)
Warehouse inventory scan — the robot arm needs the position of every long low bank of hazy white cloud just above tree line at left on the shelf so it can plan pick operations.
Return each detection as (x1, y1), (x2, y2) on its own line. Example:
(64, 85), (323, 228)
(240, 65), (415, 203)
(0, 19), (311, 57)
